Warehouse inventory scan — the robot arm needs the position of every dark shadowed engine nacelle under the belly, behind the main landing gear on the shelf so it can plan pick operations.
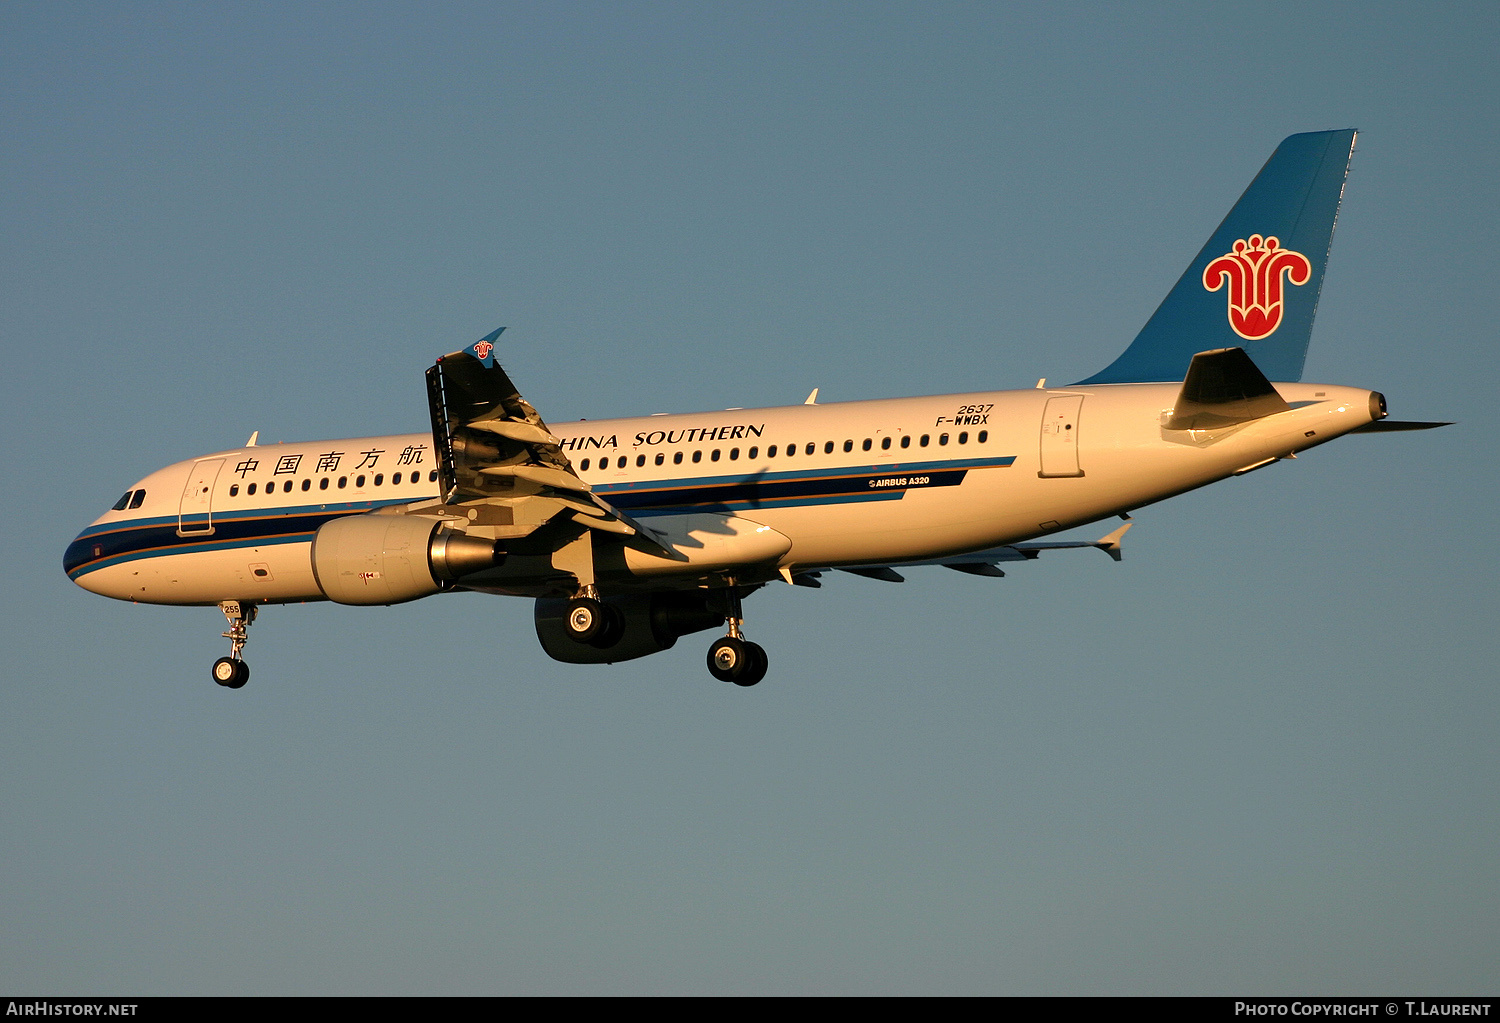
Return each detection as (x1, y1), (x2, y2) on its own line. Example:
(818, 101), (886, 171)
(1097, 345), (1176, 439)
(536, 590), (726, 665)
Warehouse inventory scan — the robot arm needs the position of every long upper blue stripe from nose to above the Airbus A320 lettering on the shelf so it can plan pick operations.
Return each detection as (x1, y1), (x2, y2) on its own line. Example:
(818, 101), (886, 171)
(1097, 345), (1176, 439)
(63, 456), (1016, 579)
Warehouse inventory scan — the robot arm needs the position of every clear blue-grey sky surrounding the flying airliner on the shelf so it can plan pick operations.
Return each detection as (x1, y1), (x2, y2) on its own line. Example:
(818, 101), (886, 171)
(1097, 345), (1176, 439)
(0, 3), (1500, 995)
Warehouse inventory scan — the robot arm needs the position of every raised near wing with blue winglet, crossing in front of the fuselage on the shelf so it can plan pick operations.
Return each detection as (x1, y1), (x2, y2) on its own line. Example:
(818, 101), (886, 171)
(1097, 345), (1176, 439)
(428, 327), (681, 560)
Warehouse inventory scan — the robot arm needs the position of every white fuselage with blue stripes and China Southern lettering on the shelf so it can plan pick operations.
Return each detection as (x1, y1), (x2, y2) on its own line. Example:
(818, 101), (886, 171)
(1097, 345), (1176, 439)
(65, 384), (1377, 605)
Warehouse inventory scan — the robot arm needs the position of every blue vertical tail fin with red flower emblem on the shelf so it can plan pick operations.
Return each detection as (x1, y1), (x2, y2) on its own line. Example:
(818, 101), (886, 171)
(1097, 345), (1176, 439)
(1079, 129), (1355, 384)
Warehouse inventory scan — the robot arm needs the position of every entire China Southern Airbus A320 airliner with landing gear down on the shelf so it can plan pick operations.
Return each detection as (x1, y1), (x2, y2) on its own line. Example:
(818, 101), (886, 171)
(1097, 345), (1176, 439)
(63, 131), (1445, 689)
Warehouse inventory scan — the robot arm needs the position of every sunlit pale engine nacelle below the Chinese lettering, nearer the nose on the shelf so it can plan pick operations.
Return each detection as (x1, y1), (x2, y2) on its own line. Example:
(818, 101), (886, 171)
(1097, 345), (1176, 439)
(312, 515), (506, 605)
